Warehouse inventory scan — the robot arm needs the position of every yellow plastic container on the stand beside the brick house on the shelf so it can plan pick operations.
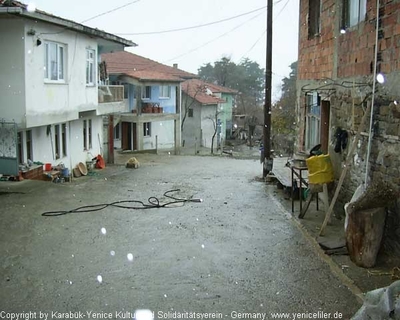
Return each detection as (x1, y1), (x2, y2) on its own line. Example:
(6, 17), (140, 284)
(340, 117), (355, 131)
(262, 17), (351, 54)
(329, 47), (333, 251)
(306, 154), (334, 184)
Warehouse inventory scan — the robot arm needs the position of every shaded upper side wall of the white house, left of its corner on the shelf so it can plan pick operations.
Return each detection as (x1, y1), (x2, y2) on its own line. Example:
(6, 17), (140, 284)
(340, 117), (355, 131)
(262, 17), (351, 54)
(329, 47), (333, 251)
(0, 18), (26, 127)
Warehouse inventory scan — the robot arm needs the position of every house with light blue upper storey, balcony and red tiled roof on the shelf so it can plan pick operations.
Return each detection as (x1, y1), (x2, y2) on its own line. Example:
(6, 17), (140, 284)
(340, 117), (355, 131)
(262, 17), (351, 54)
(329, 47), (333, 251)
(102, 51), (197, 152)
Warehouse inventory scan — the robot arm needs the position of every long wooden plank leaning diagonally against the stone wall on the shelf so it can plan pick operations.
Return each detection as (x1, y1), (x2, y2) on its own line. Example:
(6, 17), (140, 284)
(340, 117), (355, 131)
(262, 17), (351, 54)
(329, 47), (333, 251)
(319, 103), (371, 236)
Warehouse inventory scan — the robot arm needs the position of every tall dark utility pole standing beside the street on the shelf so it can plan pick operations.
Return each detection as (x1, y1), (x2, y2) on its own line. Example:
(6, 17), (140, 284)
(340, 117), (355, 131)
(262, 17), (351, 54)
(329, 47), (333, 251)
(263, 0), (273, 178)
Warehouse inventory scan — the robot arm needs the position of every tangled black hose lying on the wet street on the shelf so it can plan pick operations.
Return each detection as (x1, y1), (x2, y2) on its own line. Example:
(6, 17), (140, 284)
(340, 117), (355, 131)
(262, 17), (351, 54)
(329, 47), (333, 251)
(42, 189), (203, 217)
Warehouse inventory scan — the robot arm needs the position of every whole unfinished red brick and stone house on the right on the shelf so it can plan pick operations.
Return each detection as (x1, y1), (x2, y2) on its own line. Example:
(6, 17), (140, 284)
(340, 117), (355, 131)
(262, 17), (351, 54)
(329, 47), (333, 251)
(296, 0), (400, 254)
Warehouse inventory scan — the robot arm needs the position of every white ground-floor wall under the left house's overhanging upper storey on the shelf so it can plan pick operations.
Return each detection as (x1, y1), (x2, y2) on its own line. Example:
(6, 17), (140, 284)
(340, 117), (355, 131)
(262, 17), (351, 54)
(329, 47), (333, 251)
(32, 117), (103, 170)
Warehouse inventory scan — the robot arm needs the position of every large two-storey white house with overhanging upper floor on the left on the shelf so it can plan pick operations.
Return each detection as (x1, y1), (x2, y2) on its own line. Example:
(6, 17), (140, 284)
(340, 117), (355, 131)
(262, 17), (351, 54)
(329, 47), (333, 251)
(0, 0), (135, 175)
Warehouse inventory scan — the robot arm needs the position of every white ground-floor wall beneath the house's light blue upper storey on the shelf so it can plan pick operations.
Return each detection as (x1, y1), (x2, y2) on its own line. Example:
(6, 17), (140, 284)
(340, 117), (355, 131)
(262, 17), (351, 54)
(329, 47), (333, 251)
(141, 120), (175, 150)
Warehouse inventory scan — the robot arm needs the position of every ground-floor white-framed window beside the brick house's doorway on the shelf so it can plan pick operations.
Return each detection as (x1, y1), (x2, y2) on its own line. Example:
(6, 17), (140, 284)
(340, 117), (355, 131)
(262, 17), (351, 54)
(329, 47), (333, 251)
(305, 92), (321, 150)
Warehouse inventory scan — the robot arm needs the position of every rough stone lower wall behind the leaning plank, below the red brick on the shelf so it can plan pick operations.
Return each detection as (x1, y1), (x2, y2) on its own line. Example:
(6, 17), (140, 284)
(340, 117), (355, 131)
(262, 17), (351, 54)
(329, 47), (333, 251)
(329, 90), (400, 256)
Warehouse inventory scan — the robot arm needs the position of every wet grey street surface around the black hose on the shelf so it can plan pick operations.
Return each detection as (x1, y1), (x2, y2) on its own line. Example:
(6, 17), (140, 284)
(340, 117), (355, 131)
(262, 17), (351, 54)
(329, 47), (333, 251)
(0, 154), (360, 319)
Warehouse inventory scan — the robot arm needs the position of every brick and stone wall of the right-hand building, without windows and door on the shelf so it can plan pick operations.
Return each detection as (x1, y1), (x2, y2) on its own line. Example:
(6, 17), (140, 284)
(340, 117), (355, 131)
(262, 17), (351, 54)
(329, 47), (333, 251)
(295, 0), (400, 255)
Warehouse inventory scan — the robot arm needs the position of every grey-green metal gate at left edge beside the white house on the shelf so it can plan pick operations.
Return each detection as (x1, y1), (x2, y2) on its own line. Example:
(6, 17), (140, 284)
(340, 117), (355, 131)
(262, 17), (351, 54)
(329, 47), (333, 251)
(0, 119), (19, 176)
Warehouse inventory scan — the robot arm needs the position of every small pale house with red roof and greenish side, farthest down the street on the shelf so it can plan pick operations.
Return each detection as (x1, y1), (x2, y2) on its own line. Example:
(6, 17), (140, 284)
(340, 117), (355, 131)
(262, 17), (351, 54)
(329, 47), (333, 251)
(182, 79), (231, 149)
